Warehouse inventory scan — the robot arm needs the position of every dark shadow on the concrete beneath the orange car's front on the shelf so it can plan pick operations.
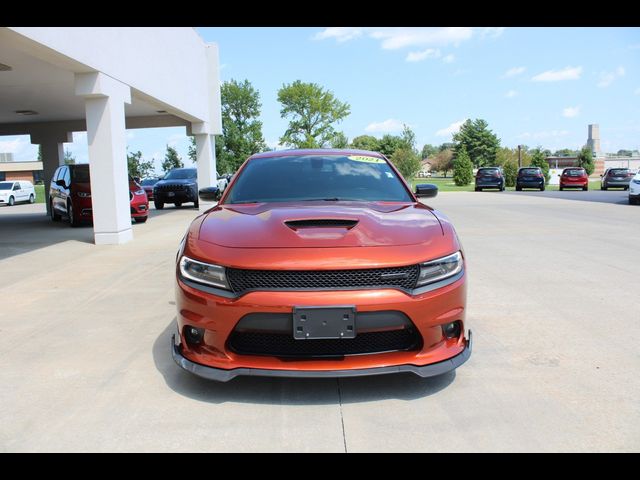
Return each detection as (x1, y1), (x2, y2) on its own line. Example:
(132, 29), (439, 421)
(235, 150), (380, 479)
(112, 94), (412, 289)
(153, 318), (456, 405)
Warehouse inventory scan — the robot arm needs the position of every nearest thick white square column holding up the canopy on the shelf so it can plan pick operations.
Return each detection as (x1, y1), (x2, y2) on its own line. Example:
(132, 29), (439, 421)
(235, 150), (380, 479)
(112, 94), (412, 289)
(76, 72), (133, 245)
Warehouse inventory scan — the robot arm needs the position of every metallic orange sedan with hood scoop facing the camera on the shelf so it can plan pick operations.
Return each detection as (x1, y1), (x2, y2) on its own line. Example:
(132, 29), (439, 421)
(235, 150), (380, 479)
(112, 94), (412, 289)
(171, 150), (471, 381)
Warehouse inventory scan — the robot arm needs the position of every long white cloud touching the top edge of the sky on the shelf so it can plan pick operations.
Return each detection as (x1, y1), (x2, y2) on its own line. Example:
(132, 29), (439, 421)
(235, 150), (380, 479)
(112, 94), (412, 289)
(313, 27), (476, 50)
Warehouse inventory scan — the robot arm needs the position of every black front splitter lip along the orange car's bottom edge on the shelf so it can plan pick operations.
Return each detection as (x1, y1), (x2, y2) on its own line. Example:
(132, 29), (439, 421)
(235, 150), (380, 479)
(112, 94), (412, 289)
(171, 330), (472, 382)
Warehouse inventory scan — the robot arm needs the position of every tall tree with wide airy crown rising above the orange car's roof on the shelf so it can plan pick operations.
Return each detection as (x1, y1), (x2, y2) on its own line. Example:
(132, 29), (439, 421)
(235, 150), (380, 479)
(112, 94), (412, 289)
(278, 80), (351, 148)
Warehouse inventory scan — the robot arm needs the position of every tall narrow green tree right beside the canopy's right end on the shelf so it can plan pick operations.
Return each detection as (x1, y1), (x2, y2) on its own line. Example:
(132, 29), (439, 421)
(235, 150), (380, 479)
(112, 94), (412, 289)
(218, 80), (267, 173)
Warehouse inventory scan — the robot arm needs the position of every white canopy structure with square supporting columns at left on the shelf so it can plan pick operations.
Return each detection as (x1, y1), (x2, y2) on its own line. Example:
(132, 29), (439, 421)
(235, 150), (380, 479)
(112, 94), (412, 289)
(0, 27), (222, 244)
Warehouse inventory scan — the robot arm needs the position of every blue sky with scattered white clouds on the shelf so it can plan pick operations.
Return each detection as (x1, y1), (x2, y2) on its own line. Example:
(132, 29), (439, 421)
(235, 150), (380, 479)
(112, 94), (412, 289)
(0, 27), (640, 171)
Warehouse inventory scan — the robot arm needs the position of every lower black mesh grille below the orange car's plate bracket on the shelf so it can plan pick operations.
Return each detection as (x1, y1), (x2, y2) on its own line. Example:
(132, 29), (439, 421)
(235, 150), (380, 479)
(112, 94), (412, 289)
(228, 328), (421, 358)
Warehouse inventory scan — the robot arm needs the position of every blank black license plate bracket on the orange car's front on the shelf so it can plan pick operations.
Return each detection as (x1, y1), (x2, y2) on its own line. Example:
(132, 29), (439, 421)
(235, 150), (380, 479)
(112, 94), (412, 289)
(293, 305), (357, 340)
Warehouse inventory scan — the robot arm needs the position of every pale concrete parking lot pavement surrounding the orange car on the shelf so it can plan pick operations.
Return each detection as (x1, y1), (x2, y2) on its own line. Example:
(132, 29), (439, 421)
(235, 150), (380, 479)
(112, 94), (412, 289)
(0, 191), (640, 452)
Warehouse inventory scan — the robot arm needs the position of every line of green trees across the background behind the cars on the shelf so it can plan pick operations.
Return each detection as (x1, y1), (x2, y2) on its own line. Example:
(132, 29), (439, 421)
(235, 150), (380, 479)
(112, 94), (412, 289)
(127, 80), (600, 186)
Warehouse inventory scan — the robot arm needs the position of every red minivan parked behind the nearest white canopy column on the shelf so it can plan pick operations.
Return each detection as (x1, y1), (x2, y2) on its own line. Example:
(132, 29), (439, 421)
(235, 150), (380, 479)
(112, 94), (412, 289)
(49, 163), (149, 227)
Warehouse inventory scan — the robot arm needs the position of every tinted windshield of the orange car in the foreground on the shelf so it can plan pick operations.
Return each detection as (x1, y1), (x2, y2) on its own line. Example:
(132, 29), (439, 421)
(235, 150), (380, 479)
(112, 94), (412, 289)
(226, 154), (413, 203)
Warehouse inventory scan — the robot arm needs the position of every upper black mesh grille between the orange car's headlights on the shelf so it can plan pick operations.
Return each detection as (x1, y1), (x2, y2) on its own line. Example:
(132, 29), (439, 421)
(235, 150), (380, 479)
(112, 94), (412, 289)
(227, 265), (419, 293)
